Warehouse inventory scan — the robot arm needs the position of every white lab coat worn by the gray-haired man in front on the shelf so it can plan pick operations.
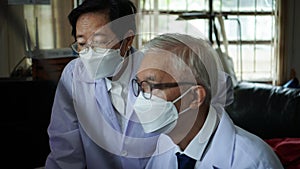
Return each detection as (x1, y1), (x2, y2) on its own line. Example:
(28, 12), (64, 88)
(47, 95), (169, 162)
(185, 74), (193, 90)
(146, 112), (283, 169)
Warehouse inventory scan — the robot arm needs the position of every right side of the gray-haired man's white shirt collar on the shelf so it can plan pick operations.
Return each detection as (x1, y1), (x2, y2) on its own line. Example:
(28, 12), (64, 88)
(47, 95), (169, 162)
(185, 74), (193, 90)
(178, 106), (220, 160)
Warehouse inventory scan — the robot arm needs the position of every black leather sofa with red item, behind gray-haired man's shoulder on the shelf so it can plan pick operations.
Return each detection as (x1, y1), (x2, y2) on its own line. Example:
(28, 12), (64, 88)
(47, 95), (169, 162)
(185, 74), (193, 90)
(226, 82), (300, 169)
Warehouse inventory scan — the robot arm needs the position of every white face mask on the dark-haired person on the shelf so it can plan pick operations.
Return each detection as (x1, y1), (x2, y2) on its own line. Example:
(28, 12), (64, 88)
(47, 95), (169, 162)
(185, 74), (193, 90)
(79, 48), (124, 80)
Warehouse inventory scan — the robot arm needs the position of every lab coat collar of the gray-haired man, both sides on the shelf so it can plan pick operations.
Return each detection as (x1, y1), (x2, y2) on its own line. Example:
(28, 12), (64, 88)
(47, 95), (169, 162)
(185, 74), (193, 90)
(153, 111), (236, 169)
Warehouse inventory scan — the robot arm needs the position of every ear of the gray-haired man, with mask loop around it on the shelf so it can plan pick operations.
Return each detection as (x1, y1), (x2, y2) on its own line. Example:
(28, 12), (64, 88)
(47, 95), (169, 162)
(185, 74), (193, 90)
(190, 85), (206, 109)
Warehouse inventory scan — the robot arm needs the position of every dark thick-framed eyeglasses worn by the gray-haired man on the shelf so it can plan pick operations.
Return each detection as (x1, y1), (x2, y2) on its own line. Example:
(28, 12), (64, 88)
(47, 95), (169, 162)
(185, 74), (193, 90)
(131, 79), (196, 100)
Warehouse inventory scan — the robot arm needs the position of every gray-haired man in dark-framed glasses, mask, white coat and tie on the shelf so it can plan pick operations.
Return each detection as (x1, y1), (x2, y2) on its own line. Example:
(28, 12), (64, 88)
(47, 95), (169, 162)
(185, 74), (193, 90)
(132, 34), (283, 169)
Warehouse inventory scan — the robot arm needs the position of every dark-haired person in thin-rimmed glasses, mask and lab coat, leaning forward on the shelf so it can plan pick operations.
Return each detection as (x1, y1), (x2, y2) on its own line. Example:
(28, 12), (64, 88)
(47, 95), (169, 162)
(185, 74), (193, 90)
(45, 0), (157, 169)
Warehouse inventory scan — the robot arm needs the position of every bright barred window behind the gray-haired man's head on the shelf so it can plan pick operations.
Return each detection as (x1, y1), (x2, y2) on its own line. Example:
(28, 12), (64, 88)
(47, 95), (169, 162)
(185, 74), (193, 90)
(138, 0), (278, 82)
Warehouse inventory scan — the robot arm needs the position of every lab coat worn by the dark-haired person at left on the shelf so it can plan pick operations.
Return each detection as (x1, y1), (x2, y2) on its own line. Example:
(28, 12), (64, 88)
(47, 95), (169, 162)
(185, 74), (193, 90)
(45, 48), (157, 169)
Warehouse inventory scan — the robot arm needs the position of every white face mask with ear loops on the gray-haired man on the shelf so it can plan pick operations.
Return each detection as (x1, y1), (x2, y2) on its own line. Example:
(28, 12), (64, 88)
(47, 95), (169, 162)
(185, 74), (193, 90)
(133, 88), (191, 133)
